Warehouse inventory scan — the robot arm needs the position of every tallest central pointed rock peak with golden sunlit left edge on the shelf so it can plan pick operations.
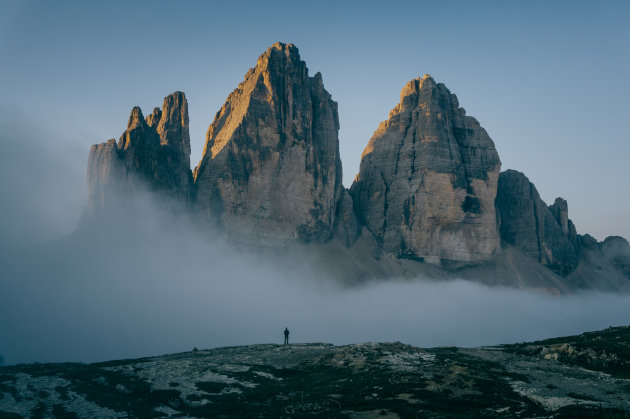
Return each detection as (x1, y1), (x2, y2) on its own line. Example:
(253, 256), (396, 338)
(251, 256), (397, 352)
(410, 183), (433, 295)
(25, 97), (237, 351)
(194, 43), (342, 244)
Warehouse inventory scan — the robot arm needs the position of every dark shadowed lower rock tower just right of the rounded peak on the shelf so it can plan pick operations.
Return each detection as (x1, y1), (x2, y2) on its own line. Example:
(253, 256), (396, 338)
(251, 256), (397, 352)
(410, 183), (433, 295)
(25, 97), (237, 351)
(496, 170), (578, 276)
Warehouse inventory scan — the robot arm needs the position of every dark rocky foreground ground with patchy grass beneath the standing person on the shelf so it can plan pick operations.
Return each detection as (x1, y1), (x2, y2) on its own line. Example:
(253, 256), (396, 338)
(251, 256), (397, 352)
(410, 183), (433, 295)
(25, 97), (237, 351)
(0, 327), (630, 418)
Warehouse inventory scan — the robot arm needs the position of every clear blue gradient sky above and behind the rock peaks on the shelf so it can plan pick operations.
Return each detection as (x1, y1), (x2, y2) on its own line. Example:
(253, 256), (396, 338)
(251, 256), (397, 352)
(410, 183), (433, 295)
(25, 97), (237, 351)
(0, 0), (630, 240)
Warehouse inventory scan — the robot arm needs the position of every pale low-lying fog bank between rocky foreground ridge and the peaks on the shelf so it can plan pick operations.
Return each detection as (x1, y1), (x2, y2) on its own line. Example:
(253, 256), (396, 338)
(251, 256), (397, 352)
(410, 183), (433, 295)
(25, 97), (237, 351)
(0, 202), (630, 364)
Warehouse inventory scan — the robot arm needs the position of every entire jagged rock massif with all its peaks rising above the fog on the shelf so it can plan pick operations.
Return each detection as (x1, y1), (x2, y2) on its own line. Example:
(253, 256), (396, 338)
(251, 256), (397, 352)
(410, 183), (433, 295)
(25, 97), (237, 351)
(86, 43), (630, 292)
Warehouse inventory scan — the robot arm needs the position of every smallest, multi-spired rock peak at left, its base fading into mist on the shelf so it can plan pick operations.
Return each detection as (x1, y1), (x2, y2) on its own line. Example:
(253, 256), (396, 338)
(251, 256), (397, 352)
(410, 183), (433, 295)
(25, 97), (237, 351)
(88, 92), (192, 214)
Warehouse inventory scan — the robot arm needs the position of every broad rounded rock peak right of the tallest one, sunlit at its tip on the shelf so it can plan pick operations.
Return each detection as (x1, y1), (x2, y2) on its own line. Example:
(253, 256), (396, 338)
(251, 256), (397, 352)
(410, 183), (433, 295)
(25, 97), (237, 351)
(351, 75), (501, 262)
